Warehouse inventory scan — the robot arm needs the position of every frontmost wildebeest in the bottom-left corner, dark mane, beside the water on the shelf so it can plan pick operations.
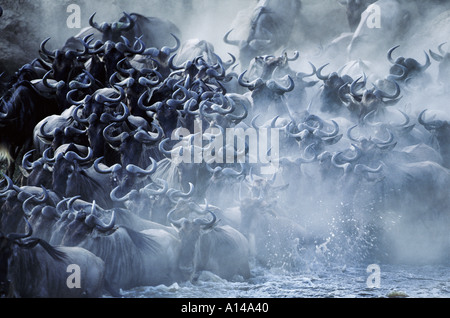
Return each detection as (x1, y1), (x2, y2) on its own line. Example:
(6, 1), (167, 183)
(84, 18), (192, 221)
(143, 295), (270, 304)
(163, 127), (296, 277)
(0, 219), (105, 298)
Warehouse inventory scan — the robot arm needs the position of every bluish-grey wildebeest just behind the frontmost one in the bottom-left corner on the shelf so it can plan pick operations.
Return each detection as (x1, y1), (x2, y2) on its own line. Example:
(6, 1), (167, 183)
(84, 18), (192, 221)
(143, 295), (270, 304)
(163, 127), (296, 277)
(56, 204), (179, 292)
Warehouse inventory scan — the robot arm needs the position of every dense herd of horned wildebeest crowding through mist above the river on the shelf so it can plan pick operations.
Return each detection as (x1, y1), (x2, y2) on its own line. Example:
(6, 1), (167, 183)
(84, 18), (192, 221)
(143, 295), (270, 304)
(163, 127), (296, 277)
(0, 1), (450, 297)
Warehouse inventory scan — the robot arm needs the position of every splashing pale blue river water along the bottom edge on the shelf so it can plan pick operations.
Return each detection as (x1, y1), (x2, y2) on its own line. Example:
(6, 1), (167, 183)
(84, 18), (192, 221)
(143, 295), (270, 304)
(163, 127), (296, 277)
(118, 258), (450, 298)
